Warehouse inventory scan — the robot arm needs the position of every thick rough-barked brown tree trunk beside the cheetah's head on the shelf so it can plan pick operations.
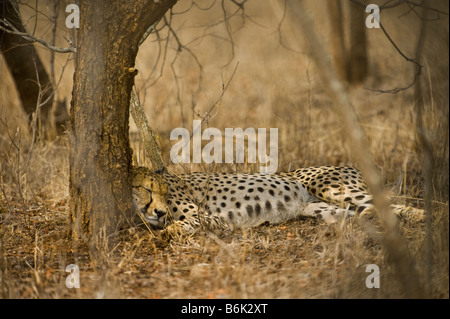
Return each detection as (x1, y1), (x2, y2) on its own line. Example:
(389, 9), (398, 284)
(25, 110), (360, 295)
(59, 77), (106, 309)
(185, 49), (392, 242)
(70, 0), (176, 247)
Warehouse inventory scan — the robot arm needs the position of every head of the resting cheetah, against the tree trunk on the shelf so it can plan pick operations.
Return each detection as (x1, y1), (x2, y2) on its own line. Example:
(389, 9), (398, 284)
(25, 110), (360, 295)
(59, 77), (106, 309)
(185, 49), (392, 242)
(132, 167), (168, 228)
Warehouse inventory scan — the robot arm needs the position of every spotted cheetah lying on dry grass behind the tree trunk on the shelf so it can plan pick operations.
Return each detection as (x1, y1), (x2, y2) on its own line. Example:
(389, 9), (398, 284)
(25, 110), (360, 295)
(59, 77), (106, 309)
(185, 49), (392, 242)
(132, 166), (423, 238)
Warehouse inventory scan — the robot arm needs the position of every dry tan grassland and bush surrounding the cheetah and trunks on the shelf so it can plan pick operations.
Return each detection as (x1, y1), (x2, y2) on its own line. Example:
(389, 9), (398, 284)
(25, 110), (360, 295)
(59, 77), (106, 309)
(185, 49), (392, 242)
(0, 0), (449, 298)
